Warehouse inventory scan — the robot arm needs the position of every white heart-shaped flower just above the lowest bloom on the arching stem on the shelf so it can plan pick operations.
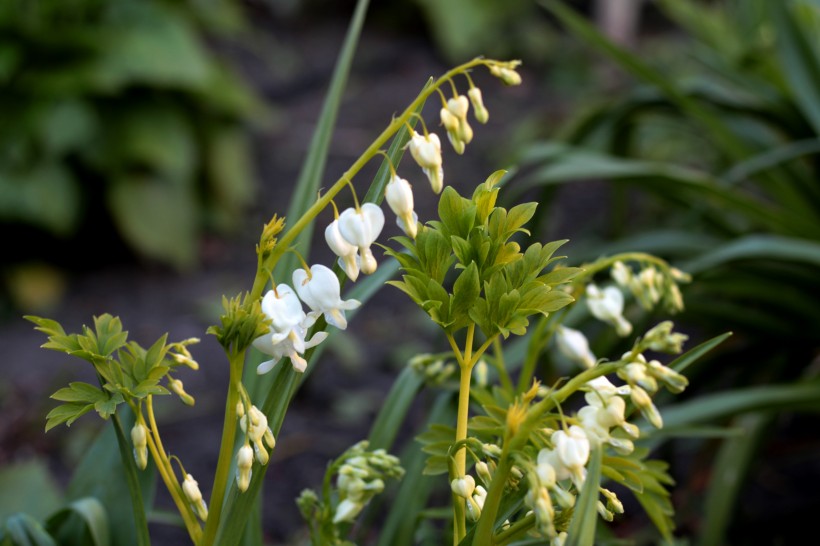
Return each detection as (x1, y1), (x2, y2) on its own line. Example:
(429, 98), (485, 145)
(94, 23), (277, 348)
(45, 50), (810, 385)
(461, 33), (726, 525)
(293, 264), (361, 330)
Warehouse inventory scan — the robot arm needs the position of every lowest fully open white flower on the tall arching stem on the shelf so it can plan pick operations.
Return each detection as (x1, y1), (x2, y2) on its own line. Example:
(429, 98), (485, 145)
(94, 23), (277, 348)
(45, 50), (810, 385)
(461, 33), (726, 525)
(253, 284), (327, 375)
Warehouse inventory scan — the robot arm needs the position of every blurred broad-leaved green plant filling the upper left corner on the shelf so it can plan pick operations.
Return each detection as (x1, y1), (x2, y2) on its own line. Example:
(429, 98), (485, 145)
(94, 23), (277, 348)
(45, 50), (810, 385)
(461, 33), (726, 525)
(0, 0), (261, 267)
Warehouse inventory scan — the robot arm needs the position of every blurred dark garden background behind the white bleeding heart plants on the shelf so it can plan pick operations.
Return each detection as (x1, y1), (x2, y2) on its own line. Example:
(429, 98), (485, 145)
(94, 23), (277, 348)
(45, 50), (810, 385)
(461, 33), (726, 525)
(0, 0), (820, 545)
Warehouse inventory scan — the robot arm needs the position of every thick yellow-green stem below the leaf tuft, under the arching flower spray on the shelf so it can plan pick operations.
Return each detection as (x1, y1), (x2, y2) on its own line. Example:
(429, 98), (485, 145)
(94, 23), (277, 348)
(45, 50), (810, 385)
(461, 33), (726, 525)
(202, 353), (244, 546)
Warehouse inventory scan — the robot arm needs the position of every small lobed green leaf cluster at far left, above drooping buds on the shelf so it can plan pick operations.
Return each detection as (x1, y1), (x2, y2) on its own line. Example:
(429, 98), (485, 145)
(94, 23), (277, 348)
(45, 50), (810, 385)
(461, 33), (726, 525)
(26, 314), (186, 431)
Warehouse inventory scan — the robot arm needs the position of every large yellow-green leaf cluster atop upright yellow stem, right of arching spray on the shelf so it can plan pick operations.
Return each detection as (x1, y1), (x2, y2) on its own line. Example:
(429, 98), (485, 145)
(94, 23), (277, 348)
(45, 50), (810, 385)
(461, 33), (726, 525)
(387, 171), (580, 338)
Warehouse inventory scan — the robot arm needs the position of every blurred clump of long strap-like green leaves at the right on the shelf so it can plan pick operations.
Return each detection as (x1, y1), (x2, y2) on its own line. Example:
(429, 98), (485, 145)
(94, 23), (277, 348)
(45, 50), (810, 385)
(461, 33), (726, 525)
(502, 0), (820, 544)
